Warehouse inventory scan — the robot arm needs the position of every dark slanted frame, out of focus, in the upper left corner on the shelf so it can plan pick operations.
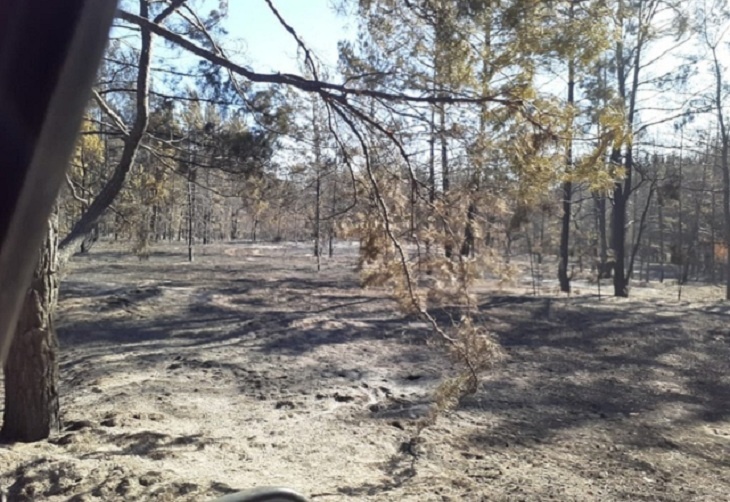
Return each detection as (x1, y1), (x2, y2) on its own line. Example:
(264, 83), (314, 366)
(0, 0), (116, 362)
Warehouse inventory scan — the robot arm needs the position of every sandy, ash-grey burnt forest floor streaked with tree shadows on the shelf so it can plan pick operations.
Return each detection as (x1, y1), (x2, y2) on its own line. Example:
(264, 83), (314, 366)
(0, 244), (730, 502)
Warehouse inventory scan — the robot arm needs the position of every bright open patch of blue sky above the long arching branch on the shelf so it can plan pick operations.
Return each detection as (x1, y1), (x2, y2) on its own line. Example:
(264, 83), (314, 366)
(223, 0), (356, 73)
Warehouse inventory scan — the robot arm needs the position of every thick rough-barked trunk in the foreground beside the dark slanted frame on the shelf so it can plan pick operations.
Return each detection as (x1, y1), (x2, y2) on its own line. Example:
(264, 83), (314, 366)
(0, 211), (60, 442)
